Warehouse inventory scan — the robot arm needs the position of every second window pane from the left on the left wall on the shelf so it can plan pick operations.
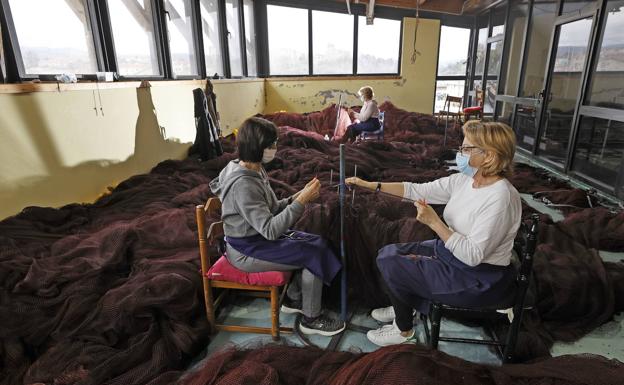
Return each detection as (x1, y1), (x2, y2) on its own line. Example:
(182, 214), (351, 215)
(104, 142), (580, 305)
(107, 0), (160, 76)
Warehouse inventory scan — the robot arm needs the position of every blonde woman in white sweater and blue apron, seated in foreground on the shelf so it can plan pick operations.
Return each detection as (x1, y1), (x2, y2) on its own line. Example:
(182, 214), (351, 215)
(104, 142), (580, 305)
(346, 121), (522, 346)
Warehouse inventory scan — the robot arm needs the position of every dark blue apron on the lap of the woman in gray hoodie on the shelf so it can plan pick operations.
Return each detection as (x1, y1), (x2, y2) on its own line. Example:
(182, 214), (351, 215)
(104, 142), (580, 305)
(226, 230), (341, 285)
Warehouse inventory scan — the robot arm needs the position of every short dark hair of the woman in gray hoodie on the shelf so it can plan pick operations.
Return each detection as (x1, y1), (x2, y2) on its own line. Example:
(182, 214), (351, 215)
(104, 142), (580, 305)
(236, 117), (277, 163)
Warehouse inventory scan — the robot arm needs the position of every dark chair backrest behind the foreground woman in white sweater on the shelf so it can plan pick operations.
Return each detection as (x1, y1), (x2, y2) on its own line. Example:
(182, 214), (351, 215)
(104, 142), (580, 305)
(514, 214), (539, 314)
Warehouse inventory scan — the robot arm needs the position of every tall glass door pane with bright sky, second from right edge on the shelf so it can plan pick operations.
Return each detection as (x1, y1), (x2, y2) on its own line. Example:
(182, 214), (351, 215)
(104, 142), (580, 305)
(536, 17), (594, 168)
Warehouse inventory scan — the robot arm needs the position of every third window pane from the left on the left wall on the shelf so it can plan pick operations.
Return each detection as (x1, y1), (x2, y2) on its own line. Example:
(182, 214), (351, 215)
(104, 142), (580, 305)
(165, 0), (198, 76)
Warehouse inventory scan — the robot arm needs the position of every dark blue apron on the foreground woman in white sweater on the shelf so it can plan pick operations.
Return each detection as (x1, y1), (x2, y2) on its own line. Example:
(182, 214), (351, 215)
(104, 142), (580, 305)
(377, 239), (516, 314)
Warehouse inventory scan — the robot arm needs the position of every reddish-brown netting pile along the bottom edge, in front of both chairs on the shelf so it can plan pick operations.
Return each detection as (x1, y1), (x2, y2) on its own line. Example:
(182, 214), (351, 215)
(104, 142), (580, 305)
(180, 344), (624, 385)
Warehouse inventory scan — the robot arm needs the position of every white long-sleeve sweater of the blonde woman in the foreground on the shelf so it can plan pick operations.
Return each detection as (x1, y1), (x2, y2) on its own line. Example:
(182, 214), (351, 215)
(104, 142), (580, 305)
(403, 173), (522, 266)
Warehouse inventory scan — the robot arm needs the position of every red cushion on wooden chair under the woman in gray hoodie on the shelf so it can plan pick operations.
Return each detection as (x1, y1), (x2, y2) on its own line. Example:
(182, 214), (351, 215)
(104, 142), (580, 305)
(206, 256), (291, 286)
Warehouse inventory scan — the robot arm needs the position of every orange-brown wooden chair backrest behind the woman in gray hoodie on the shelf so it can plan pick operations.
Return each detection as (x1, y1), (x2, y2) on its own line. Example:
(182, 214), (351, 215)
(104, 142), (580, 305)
(195, 198), (225, 268)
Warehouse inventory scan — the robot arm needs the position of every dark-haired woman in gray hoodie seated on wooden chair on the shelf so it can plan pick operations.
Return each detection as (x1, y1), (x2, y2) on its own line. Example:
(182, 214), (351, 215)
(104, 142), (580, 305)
(210, 117), (345, 336)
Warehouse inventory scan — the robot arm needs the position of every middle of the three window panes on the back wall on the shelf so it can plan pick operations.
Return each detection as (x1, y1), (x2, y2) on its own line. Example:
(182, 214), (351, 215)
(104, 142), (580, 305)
(312, 11), (354, 74)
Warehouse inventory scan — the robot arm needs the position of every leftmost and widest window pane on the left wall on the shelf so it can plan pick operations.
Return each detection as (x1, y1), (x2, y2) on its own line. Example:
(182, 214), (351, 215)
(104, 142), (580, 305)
(9, 0), (97, 75)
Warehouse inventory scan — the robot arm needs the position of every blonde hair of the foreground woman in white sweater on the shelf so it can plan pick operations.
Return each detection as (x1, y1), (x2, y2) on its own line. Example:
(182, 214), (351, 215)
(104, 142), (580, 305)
(462, 120), (516, 177)
